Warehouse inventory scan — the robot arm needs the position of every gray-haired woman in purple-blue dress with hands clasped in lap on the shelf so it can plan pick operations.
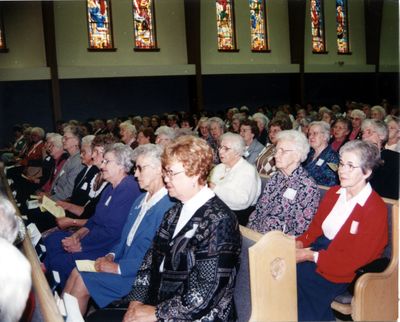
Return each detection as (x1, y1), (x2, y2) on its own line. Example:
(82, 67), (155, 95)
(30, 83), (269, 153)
(44, 143), (140, 288)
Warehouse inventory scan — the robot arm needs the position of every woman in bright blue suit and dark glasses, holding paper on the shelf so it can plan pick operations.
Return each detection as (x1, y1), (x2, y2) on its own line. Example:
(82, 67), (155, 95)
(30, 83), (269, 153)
(64, 144), (173, 314)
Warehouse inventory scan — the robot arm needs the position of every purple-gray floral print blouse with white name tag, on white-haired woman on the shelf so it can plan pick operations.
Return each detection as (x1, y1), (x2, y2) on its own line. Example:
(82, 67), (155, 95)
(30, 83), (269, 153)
(247, 166), (320, 236)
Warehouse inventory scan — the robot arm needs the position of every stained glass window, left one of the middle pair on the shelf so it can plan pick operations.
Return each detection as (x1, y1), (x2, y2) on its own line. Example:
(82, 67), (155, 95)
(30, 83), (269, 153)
(216, 0), (236, 51)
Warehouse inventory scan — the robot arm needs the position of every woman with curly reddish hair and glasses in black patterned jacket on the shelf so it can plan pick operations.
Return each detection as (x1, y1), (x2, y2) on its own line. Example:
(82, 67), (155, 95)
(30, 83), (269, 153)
(89, 136), (241, 321)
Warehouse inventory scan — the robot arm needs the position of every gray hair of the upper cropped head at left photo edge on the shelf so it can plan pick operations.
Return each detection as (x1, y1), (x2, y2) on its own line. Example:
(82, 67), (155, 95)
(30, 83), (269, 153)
(0, 195), (18, 243)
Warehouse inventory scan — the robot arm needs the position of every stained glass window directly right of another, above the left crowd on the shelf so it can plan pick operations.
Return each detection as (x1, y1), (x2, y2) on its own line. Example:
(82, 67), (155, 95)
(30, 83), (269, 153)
(133, 0), (157, 50)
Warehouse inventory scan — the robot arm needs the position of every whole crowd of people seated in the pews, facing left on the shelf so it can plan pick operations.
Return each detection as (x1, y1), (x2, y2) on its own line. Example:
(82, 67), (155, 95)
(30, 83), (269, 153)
(0, 102), (400, 322)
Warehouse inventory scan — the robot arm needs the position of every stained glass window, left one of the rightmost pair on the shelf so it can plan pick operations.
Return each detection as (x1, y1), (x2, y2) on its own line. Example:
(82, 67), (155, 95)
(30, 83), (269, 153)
(310, 0), (326, 53)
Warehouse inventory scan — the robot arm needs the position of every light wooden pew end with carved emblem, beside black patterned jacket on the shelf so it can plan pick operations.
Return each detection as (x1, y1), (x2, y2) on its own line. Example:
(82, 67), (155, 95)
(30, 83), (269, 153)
(235, 226), (297, 322)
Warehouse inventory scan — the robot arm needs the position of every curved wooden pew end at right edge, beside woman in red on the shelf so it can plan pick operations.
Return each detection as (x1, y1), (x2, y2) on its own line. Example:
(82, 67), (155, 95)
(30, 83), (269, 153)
(319, 186), (399, 321)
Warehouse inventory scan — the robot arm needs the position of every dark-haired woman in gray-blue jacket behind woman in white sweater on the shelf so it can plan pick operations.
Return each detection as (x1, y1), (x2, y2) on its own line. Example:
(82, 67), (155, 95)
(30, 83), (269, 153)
(240, 120), (265, 165)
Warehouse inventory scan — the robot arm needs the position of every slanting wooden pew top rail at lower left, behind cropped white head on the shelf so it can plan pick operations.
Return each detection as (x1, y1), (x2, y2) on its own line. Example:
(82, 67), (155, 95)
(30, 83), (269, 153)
(0, 168), (64, 322)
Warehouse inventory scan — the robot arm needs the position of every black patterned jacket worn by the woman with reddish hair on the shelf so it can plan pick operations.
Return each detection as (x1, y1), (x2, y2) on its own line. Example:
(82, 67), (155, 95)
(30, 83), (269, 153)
(126, 196), (241, 321)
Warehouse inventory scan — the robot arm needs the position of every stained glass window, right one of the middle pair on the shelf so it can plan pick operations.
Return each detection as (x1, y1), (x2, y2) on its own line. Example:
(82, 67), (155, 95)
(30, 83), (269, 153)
(249, 0), (268, 51)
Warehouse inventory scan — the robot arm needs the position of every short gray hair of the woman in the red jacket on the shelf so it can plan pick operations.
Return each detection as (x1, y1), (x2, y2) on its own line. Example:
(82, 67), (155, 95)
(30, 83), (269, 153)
(339, 140), (381, 174)
